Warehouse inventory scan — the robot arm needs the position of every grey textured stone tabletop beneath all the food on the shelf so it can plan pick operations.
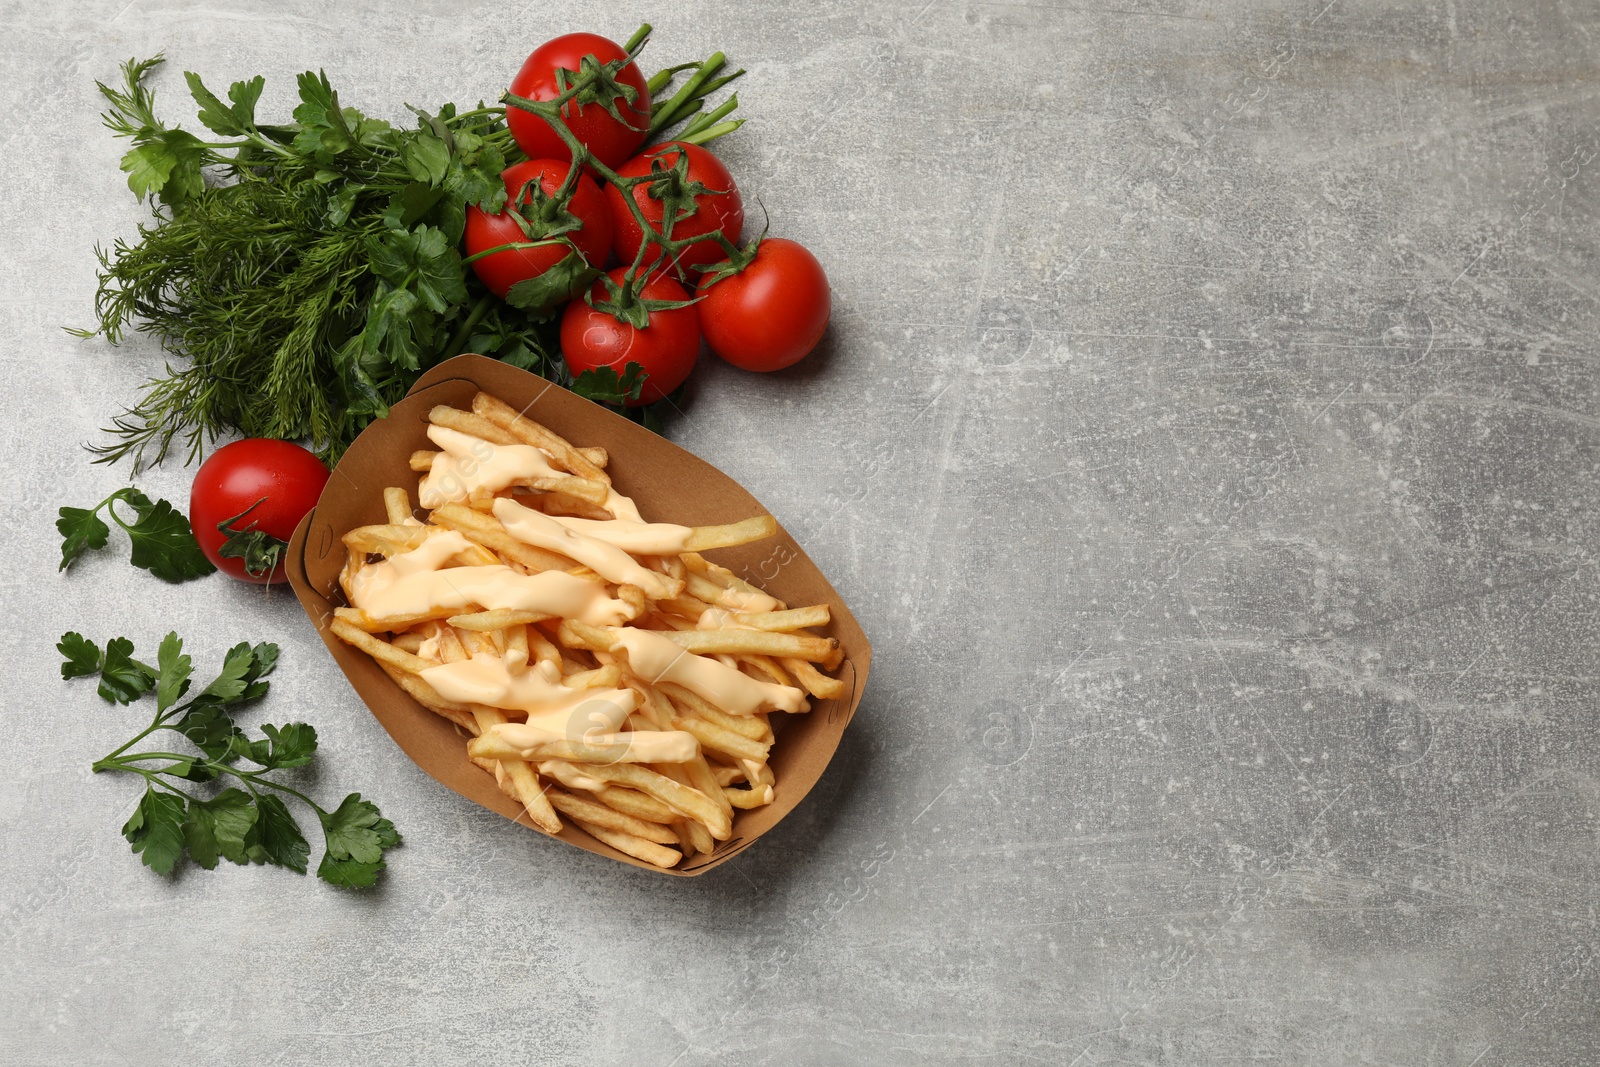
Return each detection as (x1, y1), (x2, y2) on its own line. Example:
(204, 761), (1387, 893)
(0, 0), (1600, 1067)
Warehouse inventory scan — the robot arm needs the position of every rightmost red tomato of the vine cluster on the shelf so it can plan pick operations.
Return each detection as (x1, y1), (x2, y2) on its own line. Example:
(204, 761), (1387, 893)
(694, 237), (832, 371)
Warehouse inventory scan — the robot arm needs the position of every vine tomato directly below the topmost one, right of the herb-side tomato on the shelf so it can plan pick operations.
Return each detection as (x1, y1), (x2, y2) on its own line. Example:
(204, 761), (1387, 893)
(605, 141), (744, 270)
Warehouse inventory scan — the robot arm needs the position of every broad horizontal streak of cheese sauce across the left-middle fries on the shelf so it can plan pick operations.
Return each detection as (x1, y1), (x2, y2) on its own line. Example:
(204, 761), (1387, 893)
(350, 530), (632, 627)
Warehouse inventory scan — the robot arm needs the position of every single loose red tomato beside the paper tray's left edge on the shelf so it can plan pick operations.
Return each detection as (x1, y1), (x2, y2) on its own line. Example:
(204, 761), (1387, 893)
(189, 437), (328, 585)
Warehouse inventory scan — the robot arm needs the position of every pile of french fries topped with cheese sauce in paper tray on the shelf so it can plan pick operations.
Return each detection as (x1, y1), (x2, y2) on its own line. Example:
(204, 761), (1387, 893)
(330, 394), (845, 867)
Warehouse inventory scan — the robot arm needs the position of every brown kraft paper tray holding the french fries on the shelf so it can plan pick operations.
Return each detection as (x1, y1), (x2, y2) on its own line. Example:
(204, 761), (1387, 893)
(288, 355), (872, 877)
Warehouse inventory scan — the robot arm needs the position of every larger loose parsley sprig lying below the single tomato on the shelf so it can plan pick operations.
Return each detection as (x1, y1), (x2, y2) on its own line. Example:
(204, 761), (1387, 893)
(56, 633), (400, 888)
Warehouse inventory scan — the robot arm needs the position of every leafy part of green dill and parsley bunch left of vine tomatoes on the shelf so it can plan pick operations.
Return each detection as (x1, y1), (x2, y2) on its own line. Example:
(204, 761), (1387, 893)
(76, 56), (537, 466)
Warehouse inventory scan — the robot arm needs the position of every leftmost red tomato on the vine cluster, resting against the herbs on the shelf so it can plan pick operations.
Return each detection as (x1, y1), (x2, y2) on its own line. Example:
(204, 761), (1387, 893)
(466, 160), (611, 299)
